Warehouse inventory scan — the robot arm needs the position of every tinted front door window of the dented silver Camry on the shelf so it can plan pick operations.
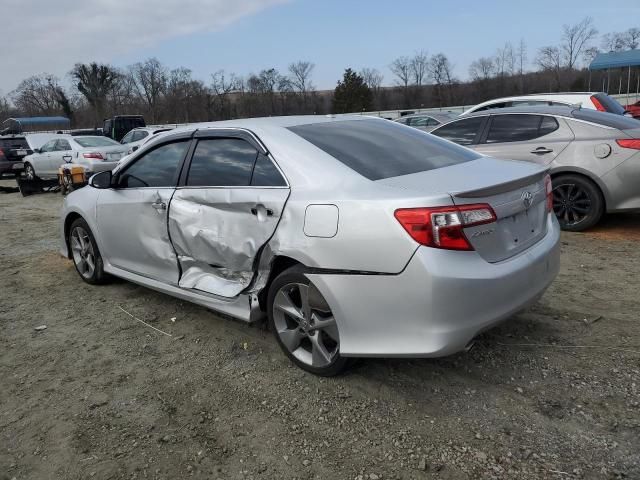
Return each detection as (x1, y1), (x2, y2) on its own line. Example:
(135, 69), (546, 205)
(118, 140), (189, 188)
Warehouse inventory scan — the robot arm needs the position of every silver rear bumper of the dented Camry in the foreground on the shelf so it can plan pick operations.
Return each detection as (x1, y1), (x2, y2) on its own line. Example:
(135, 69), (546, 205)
(308, 216), (560, 357)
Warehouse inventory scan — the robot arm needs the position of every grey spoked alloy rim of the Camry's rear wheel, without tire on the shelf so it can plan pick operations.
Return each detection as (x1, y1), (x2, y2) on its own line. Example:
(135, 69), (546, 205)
(273, 283), (340, 368)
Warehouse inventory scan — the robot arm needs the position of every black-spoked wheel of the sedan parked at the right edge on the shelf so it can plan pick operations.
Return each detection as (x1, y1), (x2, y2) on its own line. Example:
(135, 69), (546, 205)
(552, 174), (605, 232)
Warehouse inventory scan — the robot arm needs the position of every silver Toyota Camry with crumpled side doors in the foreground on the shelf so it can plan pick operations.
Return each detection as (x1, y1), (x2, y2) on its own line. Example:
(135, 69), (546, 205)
(60, 116), (560, 375)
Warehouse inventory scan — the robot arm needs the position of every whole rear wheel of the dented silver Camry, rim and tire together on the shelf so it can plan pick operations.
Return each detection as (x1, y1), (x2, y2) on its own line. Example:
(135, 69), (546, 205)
(267, 266), (348, 377)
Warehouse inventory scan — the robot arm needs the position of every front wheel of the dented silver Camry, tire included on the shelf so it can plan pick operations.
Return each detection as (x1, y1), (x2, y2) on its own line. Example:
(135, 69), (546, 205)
(69, 218), (107, 285)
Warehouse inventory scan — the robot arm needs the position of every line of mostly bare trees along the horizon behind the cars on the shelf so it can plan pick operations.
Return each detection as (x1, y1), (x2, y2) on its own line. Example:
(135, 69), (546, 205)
(0, 17), (640, 127)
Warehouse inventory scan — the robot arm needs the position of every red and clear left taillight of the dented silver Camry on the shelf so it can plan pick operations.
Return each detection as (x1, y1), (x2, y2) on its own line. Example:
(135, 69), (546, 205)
(394, 203), (496, 250)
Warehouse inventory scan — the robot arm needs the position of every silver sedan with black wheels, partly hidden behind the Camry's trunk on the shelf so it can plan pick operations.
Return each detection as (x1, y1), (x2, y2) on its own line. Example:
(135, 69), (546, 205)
(431, 107), (640, 231)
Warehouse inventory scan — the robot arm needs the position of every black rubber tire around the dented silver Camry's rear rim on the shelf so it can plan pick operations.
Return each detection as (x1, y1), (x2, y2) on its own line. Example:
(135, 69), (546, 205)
(267, 266), (349, 377)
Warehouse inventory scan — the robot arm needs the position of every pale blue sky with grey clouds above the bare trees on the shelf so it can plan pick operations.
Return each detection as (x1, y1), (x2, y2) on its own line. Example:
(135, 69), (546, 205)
(0, 0), (640, 94)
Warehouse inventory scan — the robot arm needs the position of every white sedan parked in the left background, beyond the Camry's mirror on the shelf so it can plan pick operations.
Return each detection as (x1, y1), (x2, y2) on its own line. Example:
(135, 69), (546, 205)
(24, 135), (127, 180)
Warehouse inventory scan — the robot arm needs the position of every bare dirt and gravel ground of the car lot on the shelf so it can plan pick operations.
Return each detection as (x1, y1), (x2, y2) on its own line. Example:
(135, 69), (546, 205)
(0, 181), (640, 480)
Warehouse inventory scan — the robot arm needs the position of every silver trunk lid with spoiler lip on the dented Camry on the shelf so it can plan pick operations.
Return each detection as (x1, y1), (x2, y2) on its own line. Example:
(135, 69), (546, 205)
(379, 157), (548, 263)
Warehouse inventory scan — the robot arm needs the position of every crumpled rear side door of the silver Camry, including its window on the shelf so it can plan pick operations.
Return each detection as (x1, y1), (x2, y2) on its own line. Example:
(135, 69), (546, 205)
(169, 129), (289, 297)
